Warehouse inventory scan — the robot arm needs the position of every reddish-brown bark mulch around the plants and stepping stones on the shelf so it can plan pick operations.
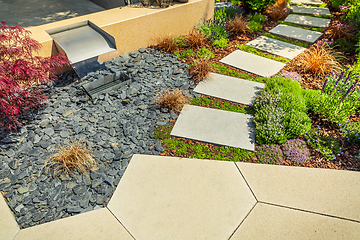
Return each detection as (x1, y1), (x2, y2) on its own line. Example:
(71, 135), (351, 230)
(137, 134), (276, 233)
(153, 7), (360, 171)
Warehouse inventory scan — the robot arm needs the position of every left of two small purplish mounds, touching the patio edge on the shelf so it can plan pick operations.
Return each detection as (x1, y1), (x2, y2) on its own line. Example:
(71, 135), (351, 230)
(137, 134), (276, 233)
(256, 144), (285, 165)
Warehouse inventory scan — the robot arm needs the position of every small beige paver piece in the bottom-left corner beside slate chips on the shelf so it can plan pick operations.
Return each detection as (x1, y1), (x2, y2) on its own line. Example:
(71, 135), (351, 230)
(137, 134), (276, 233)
(0, 193), (20, 240)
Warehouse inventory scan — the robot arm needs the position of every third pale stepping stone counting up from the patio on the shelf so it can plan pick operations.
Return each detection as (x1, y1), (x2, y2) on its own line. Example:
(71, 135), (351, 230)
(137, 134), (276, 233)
(220, 50), (286, 77)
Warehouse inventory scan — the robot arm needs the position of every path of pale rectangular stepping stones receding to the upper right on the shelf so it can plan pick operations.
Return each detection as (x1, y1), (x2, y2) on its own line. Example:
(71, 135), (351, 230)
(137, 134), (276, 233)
(171, 0), (330, 151)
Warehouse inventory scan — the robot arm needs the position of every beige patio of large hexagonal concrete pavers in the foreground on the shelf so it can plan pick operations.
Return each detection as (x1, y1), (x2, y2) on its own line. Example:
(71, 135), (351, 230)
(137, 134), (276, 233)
(0, 155), (360, 240)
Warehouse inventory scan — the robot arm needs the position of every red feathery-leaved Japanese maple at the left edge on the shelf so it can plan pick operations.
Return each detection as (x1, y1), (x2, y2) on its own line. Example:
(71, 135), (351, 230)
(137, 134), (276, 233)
(0, 21), (69, 131)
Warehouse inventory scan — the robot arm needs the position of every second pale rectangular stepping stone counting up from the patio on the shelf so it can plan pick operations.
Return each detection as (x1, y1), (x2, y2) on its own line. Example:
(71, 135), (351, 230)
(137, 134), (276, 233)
(194, 73), (265, 106)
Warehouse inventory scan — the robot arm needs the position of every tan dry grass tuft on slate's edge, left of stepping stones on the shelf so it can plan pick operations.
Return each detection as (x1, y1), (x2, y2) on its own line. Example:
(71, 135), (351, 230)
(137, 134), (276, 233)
(154, 88), (189, 112)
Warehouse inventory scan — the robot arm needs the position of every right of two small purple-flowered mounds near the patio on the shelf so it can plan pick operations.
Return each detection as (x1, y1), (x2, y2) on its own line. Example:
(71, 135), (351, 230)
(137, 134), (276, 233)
(282, 139), (310, 164)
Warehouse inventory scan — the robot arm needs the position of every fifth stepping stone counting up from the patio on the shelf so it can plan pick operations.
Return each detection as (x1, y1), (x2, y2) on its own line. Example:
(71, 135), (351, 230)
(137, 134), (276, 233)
(269, 24), (322, 43)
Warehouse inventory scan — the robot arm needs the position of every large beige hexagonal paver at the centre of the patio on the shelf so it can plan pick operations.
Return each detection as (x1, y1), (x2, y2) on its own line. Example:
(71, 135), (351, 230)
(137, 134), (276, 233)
(108, 154), (256, 240)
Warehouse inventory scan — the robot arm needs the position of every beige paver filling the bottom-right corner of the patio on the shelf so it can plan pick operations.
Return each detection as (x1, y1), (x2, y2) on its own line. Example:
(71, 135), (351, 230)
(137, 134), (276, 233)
(230, 203), (360, 240)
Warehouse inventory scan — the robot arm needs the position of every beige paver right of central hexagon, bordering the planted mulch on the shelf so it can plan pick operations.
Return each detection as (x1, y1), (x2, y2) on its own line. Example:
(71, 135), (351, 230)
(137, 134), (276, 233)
(236, 163), (360, 221)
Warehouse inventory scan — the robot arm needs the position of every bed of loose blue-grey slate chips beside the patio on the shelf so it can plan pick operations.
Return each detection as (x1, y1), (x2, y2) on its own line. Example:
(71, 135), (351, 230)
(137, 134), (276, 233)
(0, 49), (200, 228)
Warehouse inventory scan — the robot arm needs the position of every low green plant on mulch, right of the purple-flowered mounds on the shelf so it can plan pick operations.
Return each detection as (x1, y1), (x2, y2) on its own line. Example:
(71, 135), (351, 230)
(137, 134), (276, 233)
(304, 126), (343, 160)
